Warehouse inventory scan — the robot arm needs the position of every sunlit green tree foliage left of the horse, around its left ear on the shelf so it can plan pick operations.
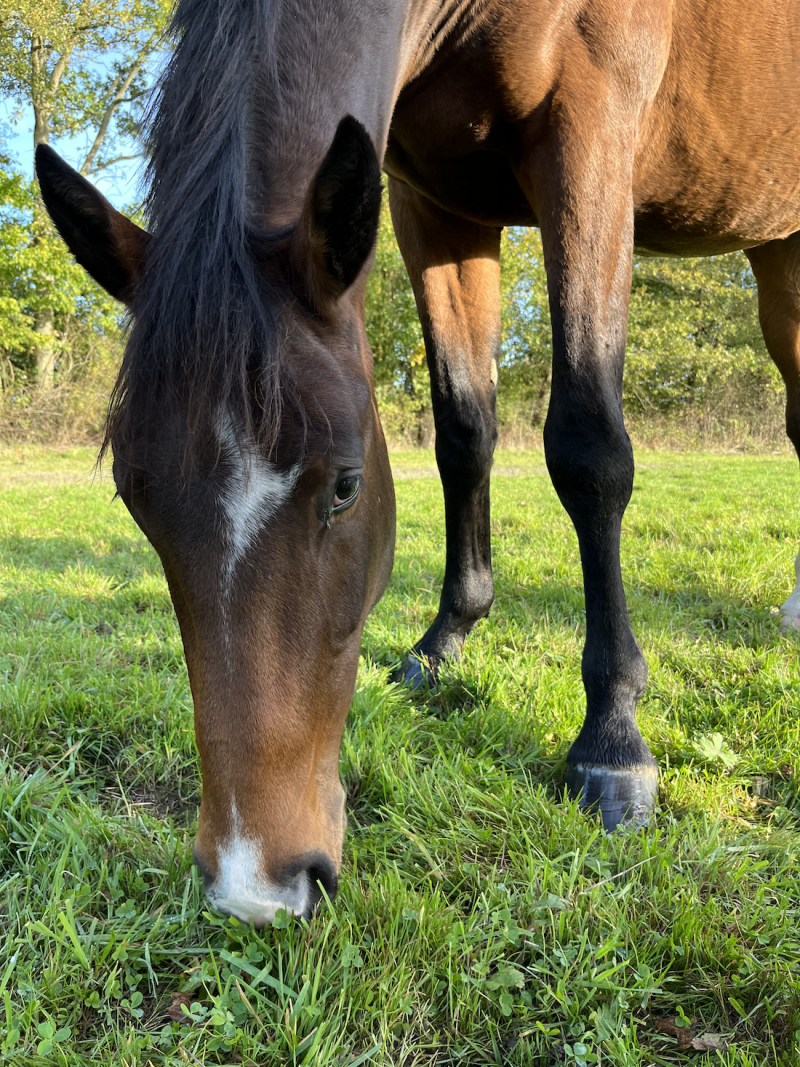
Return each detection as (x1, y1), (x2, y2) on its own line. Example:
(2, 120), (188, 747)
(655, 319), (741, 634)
(0, 0), (170, 394)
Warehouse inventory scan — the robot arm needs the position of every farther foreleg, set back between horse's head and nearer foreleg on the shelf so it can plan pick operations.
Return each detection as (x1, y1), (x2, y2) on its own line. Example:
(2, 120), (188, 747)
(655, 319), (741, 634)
(389, 179), (500, 686)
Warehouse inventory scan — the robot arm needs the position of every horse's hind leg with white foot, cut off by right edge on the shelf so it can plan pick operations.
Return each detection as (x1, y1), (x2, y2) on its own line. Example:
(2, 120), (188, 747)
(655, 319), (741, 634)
(747, 234), (800, 630)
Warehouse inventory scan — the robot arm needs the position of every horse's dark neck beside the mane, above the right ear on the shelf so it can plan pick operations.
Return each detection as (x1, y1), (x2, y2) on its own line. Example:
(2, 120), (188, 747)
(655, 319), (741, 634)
(247, 0), (475, 227)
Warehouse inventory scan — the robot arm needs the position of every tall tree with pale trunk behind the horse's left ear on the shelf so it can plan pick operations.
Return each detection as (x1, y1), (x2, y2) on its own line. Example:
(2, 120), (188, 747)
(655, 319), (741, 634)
(0, 0), (169, 387)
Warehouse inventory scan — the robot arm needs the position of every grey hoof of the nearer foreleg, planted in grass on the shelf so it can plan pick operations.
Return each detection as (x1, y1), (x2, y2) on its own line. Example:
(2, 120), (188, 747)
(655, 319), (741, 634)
(566, 763), (658, 833)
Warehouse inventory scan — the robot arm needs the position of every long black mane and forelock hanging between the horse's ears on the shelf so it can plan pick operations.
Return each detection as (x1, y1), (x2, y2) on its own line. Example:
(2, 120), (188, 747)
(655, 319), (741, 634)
(102, 0), (292, 458)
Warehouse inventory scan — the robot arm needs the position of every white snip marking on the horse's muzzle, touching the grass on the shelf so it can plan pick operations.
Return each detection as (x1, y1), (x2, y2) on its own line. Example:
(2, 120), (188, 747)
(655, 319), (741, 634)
(208, 801), (310, 925)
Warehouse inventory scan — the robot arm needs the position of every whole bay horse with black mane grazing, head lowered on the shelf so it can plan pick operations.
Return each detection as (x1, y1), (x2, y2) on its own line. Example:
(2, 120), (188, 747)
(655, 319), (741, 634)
(36, 0), (800, 925)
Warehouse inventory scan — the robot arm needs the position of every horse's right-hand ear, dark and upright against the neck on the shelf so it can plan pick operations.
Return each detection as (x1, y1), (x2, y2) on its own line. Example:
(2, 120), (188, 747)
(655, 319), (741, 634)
(292, 115), (382, 300)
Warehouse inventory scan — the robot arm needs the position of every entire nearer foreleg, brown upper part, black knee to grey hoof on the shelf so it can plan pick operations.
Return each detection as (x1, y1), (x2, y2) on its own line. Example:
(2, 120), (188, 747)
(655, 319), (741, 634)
(521, 101), (658, 829)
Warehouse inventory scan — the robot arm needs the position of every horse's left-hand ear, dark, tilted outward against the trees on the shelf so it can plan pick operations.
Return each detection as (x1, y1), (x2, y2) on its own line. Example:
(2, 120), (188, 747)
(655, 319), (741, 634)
(36, 144), (150, 303)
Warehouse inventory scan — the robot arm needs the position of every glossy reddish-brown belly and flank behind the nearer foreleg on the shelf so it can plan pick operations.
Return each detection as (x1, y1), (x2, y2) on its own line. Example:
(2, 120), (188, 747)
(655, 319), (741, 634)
(634, 0), (800, 255)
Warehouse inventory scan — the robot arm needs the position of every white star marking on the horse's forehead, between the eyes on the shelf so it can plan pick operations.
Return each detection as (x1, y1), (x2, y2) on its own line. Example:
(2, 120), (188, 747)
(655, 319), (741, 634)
(220, 418), (300, 591)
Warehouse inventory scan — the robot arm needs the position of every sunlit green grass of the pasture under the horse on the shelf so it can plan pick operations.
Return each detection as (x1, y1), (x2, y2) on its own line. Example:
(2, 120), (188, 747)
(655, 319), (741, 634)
(0, 447), (800, 1067)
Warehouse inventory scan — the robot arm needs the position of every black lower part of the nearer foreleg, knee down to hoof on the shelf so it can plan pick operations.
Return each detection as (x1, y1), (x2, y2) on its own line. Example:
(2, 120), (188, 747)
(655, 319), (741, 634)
(545, 395), (657, 829)
